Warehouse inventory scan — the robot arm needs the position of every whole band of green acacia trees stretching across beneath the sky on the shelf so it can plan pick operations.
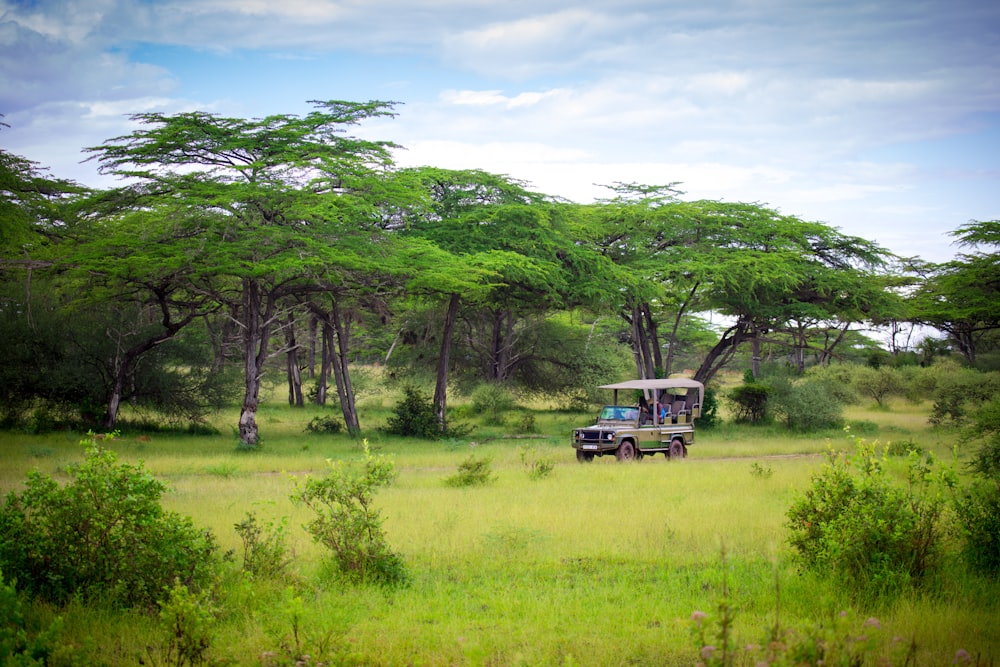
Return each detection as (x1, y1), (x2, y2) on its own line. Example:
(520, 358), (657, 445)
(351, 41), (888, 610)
(0, 100), (988, 440)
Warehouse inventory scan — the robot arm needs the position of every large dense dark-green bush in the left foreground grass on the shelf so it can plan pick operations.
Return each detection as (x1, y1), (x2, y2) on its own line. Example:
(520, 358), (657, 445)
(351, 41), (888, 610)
(0, 435), (219, 607)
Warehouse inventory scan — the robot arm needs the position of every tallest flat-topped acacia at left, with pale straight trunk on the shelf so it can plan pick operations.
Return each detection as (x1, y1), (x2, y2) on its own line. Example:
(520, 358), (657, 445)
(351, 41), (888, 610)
(88, 101), (408, 447)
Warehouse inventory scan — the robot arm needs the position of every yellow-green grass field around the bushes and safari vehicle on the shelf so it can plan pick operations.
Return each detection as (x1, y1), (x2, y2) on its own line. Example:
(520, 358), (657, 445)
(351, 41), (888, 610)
(0, 394), (1000, 665)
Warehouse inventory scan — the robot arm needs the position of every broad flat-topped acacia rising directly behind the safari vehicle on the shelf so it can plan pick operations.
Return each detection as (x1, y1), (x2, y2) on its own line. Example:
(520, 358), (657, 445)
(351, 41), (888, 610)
(584, 190), (886, 382)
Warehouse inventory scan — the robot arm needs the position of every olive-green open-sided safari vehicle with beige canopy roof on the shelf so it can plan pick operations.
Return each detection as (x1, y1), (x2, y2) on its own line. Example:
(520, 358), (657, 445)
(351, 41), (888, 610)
(573, 378), (705, 462)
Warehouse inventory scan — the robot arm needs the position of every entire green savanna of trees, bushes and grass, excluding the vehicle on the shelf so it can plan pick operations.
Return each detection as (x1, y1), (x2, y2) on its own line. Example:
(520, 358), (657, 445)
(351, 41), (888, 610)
(0, 101), (1000, 666)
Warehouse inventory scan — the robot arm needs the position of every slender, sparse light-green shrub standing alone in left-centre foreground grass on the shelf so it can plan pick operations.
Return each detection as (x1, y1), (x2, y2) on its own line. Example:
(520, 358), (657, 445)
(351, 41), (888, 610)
(292, 440), (407, 584)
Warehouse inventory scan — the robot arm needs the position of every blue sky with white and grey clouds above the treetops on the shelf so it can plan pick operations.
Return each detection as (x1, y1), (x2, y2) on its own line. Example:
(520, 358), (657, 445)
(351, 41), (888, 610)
(0, 0), (1000, 262)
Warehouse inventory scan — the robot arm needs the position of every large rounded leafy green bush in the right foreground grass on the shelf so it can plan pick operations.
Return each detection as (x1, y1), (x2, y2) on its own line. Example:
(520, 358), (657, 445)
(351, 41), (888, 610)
(786, 430), (951, 601)
